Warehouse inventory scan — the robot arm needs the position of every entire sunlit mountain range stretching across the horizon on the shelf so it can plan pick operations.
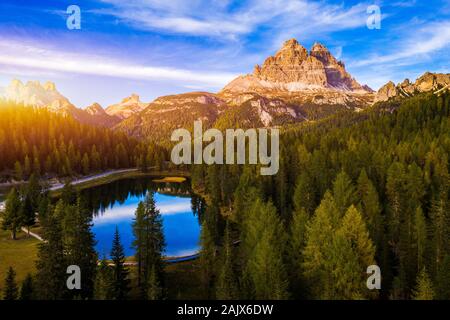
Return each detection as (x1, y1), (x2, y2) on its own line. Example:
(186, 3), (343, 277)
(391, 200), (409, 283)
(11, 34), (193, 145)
(4, 39), (450, 140)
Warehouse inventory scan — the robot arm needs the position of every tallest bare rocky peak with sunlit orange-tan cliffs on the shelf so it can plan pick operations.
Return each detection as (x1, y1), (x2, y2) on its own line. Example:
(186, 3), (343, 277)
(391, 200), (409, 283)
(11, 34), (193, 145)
(222, 39), (371, 94)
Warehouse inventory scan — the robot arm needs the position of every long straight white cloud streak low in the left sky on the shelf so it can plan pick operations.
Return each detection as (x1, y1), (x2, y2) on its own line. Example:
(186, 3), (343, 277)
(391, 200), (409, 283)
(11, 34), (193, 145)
(0, 40), (236, 88)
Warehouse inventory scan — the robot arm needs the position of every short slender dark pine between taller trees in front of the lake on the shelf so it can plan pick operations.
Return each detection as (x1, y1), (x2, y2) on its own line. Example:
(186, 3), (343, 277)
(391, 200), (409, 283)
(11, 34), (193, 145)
(110, 227), (130, 300)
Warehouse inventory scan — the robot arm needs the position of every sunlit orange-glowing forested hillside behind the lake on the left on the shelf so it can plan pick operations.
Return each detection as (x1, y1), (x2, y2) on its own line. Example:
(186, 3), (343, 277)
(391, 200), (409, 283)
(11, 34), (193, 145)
(0, 102), (166, 181)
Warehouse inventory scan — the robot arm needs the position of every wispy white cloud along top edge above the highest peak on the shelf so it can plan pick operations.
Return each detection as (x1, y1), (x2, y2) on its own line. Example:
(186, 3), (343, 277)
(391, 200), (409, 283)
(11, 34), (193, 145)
(91, 0), (367, 40)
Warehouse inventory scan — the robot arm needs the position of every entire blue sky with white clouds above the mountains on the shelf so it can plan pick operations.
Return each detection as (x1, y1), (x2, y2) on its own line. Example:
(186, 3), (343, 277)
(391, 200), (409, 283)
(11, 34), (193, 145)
(0, 0), (450, 107)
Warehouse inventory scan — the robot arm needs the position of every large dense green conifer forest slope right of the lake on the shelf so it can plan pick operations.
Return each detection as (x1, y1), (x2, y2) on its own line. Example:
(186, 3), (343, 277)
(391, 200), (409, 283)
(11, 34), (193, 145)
(192, 93), (450, 299)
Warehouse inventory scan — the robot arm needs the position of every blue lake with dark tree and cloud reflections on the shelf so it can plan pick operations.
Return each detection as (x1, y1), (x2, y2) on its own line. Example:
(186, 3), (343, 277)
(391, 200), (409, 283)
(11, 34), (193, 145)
(78, 178), (201, 257)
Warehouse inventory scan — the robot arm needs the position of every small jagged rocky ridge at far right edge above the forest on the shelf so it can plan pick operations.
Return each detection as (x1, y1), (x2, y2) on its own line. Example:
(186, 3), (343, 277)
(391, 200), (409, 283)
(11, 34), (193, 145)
(375, 72), (450, 102)
